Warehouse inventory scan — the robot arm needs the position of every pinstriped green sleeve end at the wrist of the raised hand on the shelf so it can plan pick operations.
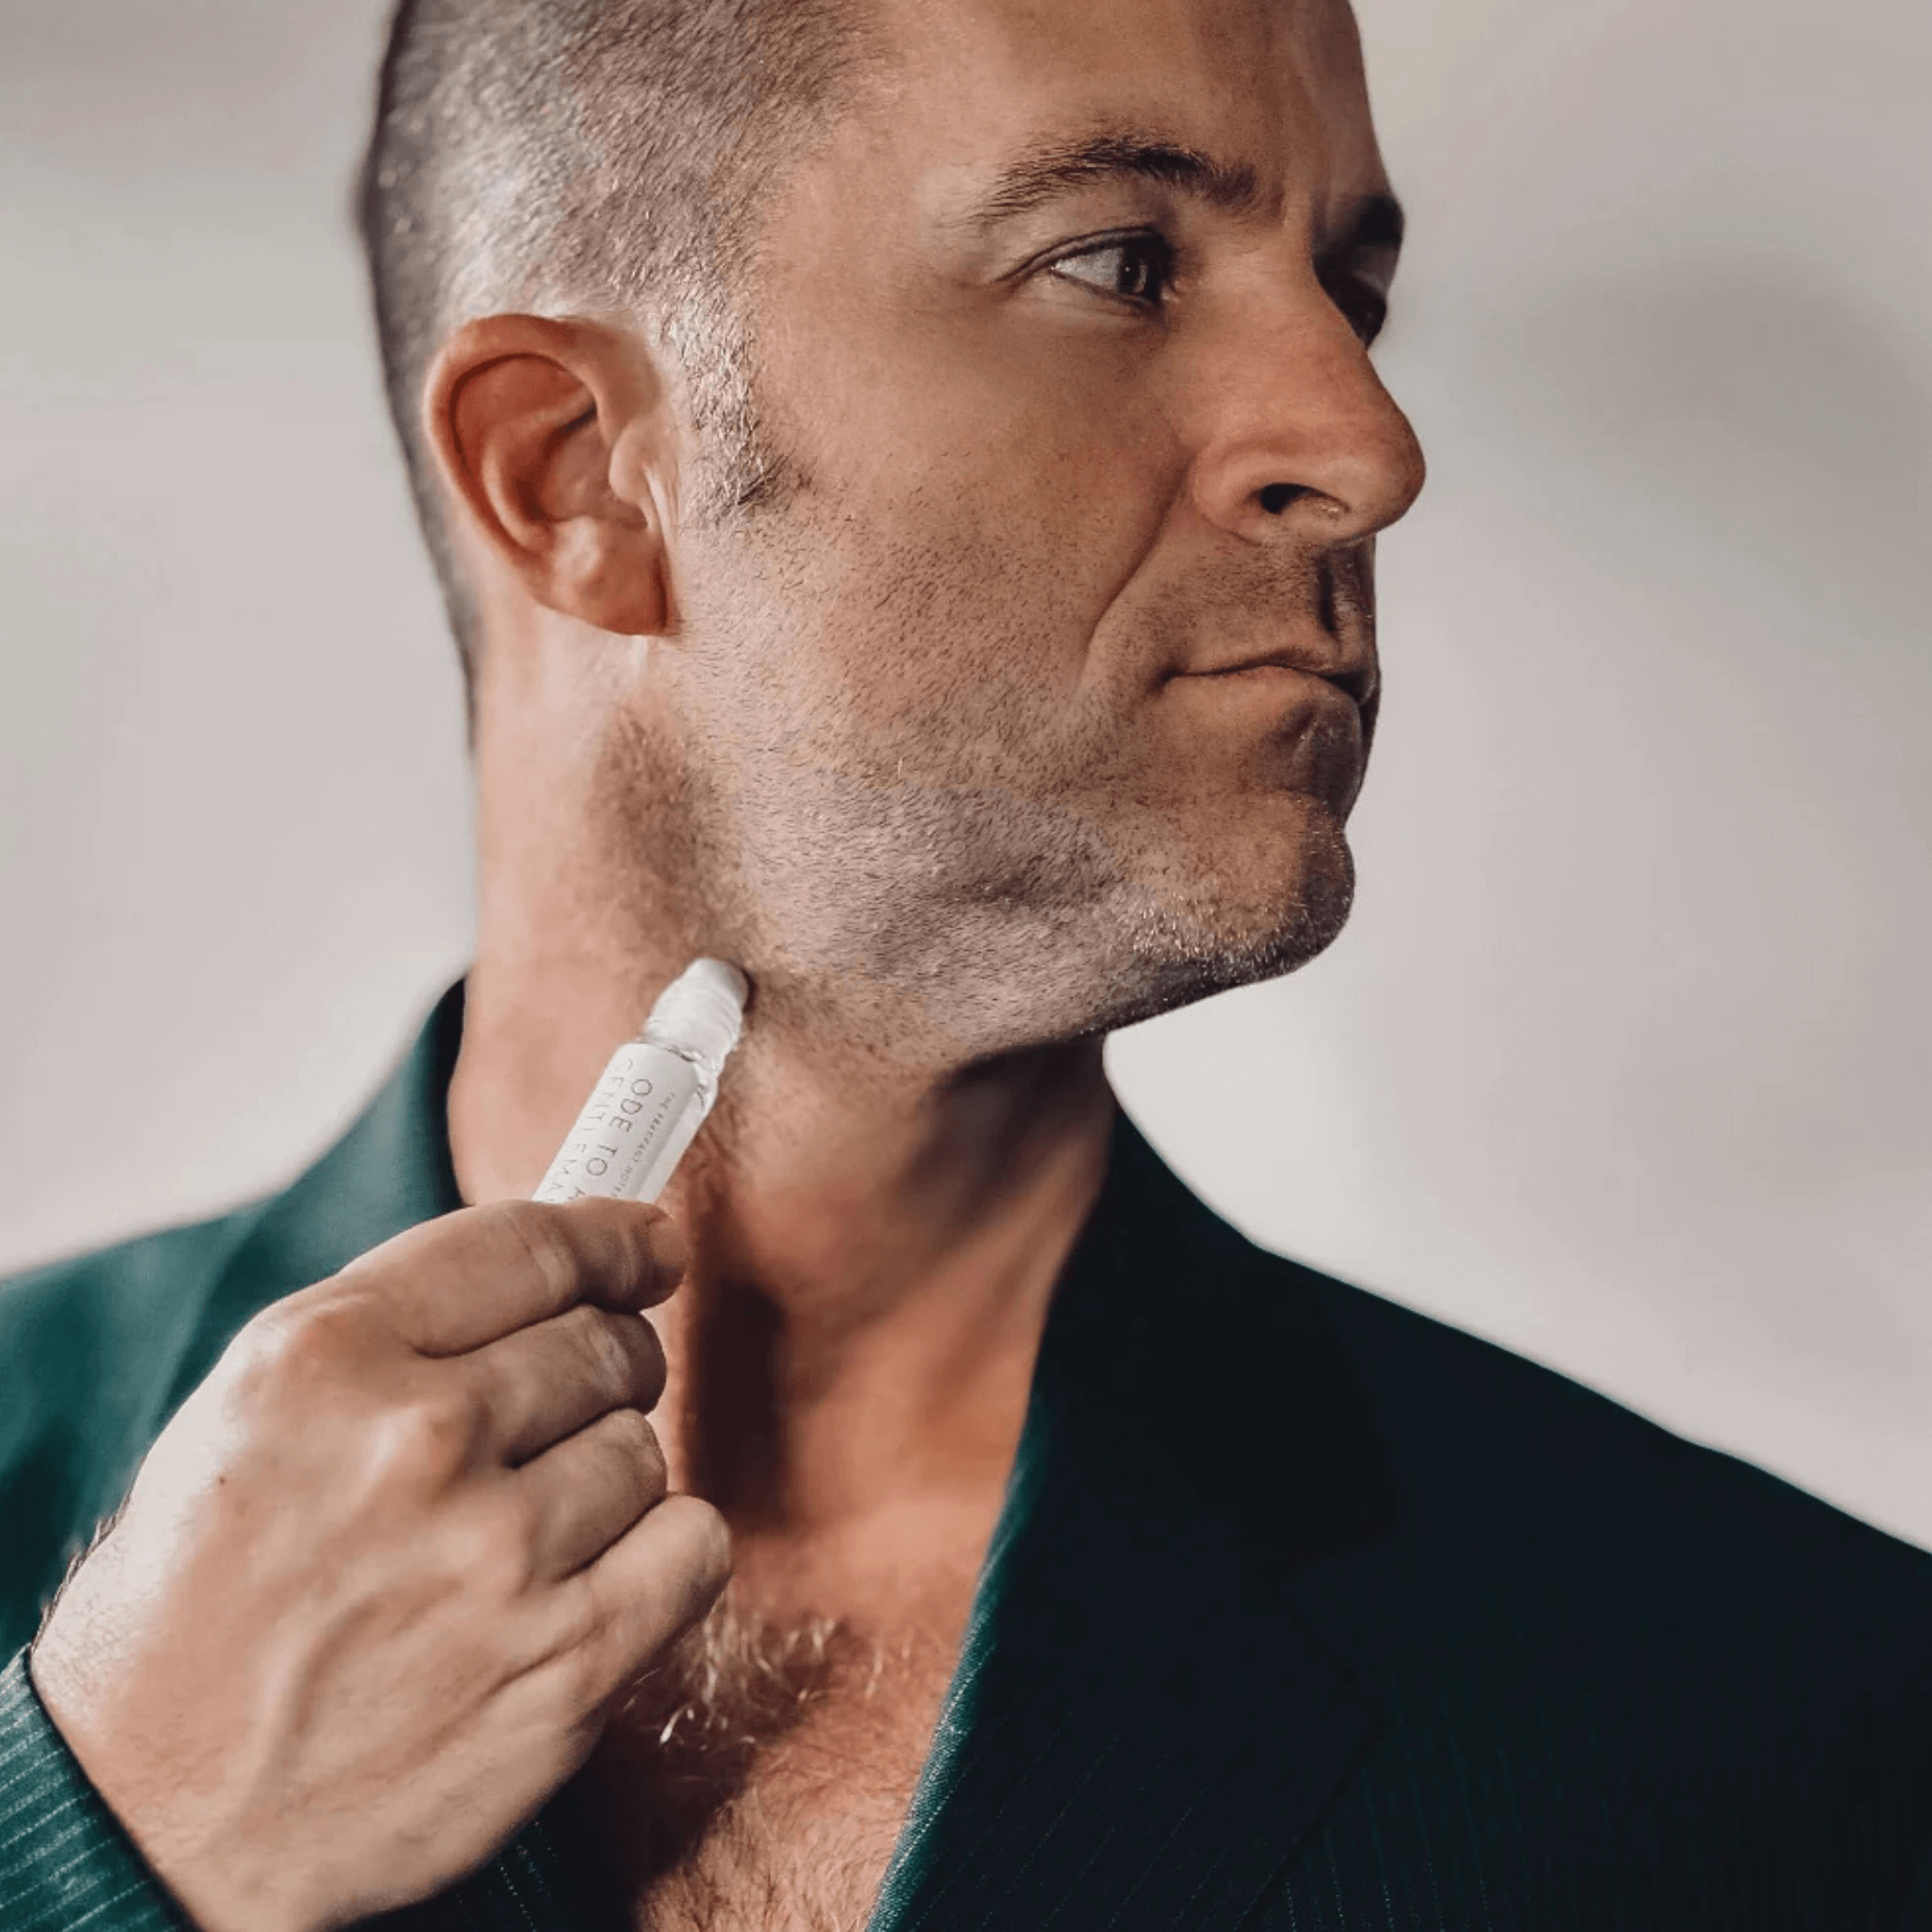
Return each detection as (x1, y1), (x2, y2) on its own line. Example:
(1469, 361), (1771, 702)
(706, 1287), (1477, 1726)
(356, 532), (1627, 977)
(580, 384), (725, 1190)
(0, 1656), (186, 1932)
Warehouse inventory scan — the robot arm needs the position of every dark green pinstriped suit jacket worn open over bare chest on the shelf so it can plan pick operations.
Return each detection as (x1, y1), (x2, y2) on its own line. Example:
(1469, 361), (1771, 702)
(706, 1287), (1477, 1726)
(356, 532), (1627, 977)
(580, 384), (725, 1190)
(0, 995), (1932, 1932)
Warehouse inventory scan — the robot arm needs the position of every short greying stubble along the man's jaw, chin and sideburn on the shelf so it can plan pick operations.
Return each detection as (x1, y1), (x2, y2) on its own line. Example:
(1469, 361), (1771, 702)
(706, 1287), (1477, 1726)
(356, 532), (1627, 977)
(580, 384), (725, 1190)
(601, 326), (1355, 1060)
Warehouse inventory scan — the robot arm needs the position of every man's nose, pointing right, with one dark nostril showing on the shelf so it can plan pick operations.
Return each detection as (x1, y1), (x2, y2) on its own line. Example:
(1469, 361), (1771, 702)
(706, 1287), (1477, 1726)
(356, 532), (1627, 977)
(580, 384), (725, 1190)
(1192, 288), (1424, 549)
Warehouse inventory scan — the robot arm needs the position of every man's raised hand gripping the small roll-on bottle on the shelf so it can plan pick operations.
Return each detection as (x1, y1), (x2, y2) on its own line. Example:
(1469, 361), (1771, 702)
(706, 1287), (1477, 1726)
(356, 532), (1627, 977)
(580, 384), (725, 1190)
(33, 1200), (728, 1932)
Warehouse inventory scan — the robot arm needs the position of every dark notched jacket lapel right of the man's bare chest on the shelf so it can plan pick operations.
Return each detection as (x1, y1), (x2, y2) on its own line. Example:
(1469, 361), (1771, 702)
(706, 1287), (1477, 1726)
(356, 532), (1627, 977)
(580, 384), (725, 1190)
(872, 1121), (1387, 1932)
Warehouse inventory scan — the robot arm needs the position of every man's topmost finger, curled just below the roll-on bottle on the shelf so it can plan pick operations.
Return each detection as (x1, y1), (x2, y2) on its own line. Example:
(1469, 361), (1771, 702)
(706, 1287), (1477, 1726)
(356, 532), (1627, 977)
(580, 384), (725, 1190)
(336, 1196), (684, 1355)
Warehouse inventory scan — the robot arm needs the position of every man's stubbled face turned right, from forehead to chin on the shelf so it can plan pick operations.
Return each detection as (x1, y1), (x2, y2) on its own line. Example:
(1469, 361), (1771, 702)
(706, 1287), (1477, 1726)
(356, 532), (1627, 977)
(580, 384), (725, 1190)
(657, 0), (1422, 1053)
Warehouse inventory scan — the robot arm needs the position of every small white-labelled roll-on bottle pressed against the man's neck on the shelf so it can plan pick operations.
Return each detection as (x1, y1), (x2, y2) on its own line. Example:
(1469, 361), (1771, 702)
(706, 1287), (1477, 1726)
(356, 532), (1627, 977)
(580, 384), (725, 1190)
(535, 960), (752, 1202)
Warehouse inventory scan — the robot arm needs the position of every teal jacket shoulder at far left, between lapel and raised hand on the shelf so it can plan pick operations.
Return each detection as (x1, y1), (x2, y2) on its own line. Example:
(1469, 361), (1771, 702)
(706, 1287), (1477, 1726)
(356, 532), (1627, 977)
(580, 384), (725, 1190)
(0, 1208), (260, 1656)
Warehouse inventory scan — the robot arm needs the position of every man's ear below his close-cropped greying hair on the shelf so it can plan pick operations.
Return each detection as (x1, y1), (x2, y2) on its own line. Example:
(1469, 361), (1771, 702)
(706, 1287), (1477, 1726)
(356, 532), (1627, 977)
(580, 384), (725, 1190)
(424, 315), (676, 636)
